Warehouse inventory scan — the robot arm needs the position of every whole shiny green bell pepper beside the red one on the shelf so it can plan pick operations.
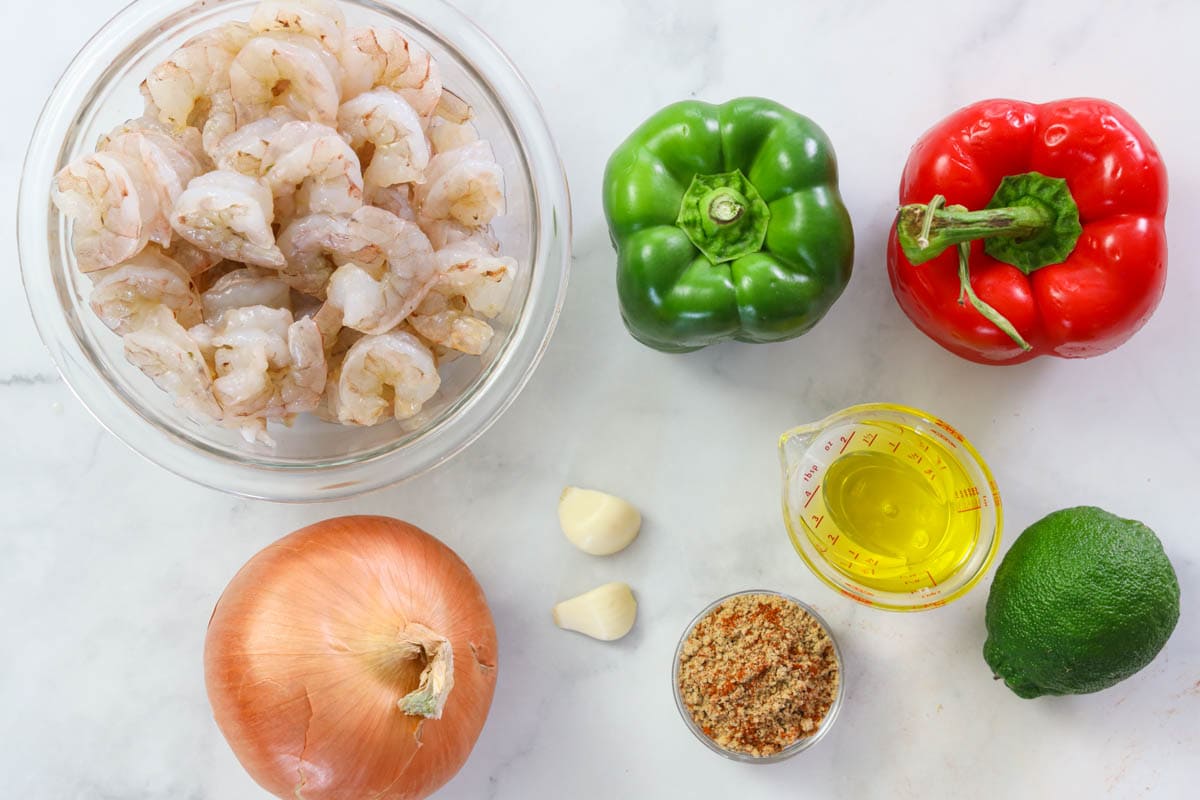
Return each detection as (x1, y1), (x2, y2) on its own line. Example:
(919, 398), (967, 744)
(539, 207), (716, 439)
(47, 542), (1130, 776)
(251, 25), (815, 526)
(604, 97), (854, 353)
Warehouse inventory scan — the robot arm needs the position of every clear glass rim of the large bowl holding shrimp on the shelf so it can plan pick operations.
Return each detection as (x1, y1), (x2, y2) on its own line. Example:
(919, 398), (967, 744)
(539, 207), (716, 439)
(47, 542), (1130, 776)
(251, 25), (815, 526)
(17, 0), (571, 503)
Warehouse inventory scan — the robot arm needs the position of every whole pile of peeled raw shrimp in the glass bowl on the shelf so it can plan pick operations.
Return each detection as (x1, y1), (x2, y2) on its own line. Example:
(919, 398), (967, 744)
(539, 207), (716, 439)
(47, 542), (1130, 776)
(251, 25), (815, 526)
(53, 0), (516, 444)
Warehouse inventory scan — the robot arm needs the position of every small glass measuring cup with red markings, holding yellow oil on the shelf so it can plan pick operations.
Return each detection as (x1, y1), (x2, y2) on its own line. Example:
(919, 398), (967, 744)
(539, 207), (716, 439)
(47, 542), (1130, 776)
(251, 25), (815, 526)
(779, 403), (1002, 610)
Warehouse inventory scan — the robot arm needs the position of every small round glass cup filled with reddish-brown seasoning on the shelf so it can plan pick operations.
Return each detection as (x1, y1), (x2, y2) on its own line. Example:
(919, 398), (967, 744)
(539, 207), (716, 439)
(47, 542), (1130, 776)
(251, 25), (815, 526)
(676, 594), (840, 757)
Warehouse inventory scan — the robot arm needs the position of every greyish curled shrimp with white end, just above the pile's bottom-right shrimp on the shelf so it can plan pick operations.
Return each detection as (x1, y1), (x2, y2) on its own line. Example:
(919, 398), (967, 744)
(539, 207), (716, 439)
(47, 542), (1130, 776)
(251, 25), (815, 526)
(326, 209), (437, 335)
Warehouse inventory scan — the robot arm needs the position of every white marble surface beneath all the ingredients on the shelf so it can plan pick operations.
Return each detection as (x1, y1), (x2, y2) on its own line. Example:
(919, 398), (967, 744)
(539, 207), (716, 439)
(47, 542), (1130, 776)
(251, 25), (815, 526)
(0, 0), (1200, 800)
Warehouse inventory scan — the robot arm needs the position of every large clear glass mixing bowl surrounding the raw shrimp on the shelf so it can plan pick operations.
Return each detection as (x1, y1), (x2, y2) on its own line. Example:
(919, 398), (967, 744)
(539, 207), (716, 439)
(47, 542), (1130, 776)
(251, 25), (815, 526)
(18, 0), (571, 501)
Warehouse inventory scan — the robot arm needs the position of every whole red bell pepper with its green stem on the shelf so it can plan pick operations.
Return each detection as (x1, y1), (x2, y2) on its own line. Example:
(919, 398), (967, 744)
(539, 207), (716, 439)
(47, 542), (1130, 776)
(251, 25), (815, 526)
(888, 98), (1166, 363)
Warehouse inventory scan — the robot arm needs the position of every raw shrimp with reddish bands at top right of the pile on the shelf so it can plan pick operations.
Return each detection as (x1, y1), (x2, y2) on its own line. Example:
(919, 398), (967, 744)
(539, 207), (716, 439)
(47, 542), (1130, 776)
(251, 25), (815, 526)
(341, 28), (442, 118)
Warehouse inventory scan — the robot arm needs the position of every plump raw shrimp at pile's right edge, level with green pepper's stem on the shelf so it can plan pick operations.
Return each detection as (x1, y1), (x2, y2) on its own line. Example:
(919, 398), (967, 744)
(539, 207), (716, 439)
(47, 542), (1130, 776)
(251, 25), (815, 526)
(416, 140), (504, 227)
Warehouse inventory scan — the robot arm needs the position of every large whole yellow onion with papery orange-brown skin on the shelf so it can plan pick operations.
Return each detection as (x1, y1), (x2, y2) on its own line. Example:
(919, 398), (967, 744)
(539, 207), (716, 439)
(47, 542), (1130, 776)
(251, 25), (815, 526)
(204, 517), (497, 800)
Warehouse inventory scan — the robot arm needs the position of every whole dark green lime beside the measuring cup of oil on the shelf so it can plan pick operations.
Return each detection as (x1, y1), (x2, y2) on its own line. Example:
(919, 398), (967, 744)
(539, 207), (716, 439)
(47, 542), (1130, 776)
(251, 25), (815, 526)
(983, 506), (1180, 697)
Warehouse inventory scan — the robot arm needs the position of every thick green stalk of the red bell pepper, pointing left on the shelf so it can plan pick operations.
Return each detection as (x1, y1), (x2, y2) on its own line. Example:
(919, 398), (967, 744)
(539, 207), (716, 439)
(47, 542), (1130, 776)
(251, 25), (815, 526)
(896, 200), (1055, 264)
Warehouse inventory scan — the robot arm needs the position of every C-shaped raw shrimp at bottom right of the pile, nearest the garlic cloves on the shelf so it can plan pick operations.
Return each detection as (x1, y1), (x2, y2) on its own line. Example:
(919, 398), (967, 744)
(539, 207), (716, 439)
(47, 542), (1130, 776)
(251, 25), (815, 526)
(326, 332), (442, 425)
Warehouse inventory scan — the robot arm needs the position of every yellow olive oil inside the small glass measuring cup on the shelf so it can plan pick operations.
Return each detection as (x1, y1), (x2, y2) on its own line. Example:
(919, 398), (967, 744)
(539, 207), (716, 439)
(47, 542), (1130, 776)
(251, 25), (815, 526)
(805, 423), (980, 591)
